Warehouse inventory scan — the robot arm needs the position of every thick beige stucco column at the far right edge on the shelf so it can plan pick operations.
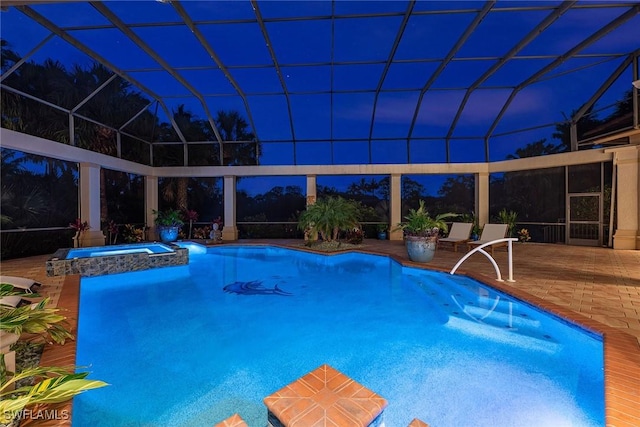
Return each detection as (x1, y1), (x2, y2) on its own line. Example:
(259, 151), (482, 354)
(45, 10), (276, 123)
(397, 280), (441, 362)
(607, 145), (640, 249)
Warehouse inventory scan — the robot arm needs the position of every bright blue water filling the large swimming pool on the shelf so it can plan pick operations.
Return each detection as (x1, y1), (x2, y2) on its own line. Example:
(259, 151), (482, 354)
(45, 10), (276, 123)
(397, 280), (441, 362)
(73, 246), (604, 427)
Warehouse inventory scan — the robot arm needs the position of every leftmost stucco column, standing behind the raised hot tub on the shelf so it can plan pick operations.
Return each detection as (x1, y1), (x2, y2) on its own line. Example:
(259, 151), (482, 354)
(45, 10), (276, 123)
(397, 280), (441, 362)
(79, 163), (105, 246)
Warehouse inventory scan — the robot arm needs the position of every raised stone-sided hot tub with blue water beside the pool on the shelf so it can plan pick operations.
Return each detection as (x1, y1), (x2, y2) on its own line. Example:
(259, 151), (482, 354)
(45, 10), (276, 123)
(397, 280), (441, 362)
(47, 242), (189, 277)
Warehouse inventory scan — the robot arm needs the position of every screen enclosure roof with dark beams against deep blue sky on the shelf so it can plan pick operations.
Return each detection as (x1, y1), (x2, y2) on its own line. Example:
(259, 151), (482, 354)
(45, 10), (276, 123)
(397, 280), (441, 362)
(1, 0), (640, 163)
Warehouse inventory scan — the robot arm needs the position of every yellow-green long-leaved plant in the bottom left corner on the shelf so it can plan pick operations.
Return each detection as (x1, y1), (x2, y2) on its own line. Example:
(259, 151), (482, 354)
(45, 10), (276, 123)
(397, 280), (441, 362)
(0, 354), (108, 423)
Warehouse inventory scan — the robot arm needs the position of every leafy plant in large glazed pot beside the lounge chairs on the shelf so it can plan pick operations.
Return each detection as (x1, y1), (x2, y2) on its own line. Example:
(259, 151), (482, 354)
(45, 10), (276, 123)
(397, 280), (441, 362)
(398, 200), (458, 262)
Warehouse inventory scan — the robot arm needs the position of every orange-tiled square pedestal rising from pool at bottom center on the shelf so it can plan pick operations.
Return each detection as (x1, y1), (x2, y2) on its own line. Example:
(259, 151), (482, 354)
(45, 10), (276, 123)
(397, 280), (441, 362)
(264, 365), (387, 427)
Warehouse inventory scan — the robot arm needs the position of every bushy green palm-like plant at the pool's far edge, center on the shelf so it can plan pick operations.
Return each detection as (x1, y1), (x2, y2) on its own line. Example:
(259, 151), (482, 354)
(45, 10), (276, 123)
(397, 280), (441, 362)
(298, 197), (360, 242)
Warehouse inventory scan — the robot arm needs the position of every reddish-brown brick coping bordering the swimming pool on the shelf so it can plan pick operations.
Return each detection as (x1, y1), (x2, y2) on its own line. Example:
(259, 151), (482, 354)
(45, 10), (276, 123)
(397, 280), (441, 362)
(36, 242), (640, 427)
